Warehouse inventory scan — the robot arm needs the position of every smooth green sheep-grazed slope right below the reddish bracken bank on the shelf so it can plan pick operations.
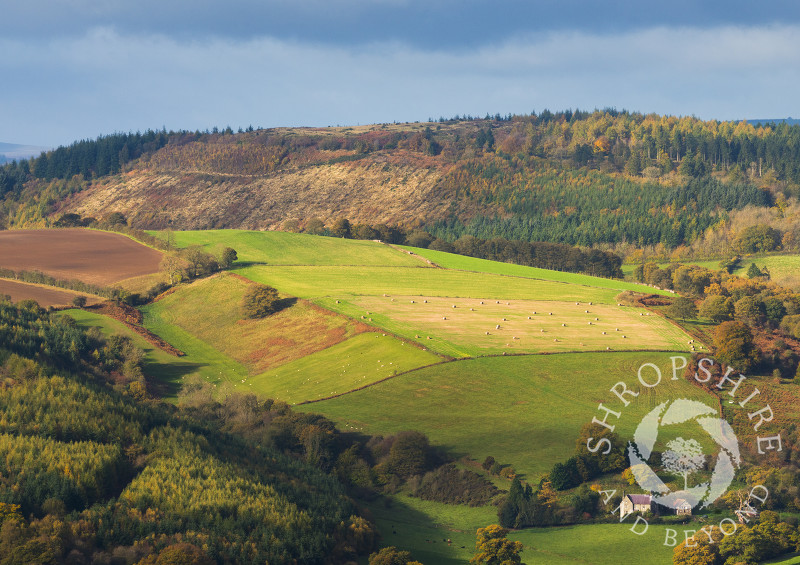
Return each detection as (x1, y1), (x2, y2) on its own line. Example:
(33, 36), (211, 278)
(250, 332), (442, 403)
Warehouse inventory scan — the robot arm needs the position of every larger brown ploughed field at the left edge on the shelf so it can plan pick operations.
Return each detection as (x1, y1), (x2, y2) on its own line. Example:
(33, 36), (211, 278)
(0, 228), (162, 286)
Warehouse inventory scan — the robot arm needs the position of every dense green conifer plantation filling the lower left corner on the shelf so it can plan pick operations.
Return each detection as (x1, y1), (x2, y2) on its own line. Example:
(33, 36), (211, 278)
(0, 301), (375, 564)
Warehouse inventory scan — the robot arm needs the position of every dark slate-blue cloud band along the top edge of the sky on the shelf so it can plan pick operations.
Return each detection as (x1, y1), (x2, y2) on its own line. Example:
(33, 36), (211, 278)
(0, 0), (800, 49)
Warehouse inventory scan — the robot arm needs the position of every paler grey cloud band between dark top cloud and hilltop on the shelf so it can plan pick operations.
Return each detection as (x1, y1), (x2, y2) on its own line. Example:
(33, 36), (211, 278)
(0, 25), (800, 145)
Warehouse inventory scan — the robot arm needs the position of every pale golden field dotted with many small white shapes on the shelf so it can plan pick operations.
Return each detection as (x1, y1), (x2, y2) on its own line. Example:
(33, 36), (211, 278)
(317, 295), (691, 357)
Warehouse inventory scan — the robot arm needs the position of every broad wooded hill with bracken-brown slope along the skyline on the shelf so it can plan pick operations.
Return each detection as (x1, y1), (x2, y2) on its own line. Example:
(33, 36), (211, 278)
(0, 110), (800, 256)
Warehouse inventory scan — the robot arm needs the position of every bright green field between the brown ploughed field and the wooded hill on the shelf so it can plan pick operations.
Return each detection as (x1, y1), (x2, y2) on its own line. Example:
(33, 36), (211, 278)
(158, 230), (426, 267)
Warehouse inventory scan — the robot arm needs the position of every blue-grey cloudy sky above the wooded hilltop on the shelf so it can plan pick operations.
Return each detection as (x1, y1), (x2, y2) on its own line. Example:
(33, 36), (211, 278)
(0, 0), (800, 147)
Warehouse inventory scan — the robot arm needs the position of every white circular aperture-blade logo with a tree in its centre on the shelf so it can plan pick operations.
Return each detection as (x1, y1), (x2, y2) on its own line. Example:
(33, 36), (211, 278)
(628, 398), (741, 510)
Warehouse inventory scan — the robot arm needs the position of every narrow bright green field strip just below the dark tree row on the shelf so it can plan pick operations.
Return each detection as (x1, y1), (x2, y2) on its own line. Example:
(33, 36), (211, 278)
(399, 245), (670, 295)
